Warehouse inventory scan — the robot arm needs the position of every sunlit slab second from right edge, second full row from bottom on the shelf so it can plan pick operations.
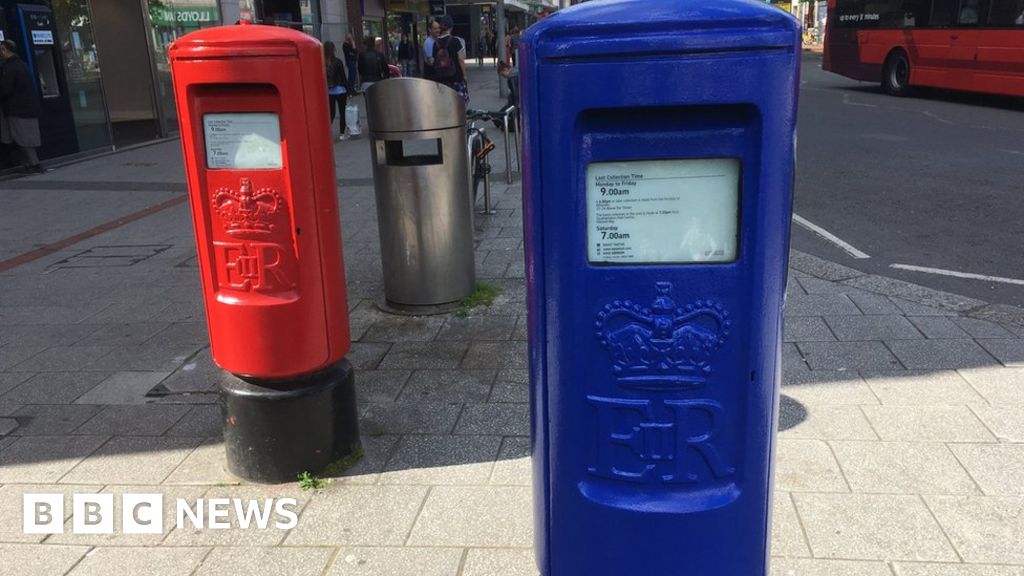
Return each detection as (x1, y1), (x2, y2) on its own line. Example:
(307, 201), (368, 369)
(829, 441), (979, 494)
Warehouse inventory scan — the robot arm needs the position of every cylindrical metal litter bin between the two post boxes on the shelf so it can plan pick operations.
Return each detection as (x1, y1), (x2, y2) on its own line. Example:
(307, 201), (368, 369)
(366, 78), (476, 314)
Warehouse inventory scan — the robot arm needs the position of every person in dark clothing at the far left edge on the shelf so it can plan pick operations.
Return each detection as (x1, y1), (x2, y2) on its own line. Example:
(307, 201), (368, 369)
(0, 40), (45, 174)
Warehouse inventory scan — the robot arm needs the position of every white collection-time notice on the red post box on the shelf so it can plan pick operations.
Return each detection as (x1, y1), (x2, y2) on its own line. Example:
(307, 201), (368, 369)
(203, 112), (282, 170)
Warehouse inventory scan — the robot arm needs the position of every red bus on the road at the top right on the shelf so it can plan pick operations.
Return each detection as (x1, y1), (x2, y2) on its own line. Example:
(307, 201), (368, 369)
(822, 0), (1024, 96)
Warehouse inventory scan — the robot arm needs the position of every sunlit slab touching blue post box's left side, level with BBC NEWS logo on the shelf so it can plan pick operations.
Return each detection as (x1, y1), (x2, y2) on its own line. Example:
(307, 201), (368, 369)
(408, 486), (534, 547)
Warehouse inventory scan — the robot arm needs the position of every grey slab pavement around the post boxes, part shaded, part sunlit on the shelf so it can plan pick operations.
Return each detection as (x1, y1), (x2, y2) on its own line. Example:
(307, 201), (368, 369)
(0, 62), (1024, 576)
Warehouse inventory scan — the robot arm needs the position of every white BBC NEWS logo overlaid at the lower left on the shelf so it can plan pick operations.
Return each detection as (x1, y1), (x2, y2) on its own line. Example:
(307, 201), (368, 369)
(23, 494), (299, 534)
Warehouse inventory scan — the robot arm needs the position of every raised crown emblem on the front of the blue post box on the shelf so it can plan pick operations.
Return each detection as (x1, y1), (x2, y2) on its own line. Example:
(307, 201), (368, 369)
(595, 282), (732, 389)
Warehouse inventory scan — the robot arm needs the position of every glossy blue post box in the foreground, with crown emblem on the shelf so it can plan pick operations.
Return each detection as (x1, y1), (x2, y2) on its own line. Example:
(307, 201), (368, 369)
(520, 0), (800, 576)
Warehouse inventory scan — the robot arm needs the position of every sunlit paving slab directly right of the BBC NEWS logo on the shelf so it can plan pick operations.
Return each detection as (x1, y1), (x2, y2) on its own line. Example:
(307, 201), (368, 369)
(285, 484), (428, 546)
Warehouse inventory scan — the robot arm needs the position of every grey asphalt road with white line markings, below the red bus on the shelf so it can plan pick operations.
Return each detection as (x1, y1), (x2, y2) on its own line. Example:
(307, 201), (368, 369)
(793, 53), (1024, 306)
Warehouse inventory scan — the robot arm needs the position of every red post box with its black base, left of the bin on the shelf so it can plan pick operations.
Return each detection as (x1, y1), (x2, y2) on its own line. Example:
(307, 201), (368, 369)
(169, 25), (358, 481)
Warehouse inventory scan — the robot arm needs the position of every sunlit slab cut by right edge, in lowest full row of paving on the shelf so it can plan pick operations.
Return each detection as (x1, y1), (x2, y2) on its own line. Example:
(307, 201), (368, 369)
(925, 495), (1024, 565)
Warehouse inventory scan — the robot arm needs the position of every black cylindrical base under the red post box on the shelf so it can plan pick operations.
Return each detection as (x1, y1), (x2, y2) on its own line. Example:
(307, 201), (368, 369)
(220, 360), (359, 484)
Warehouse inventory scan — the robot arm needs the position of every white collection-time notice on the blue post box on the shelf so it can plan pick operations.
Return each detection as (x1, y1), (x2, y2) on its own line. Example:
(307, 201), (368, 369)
(587, 158), (739, 263)
